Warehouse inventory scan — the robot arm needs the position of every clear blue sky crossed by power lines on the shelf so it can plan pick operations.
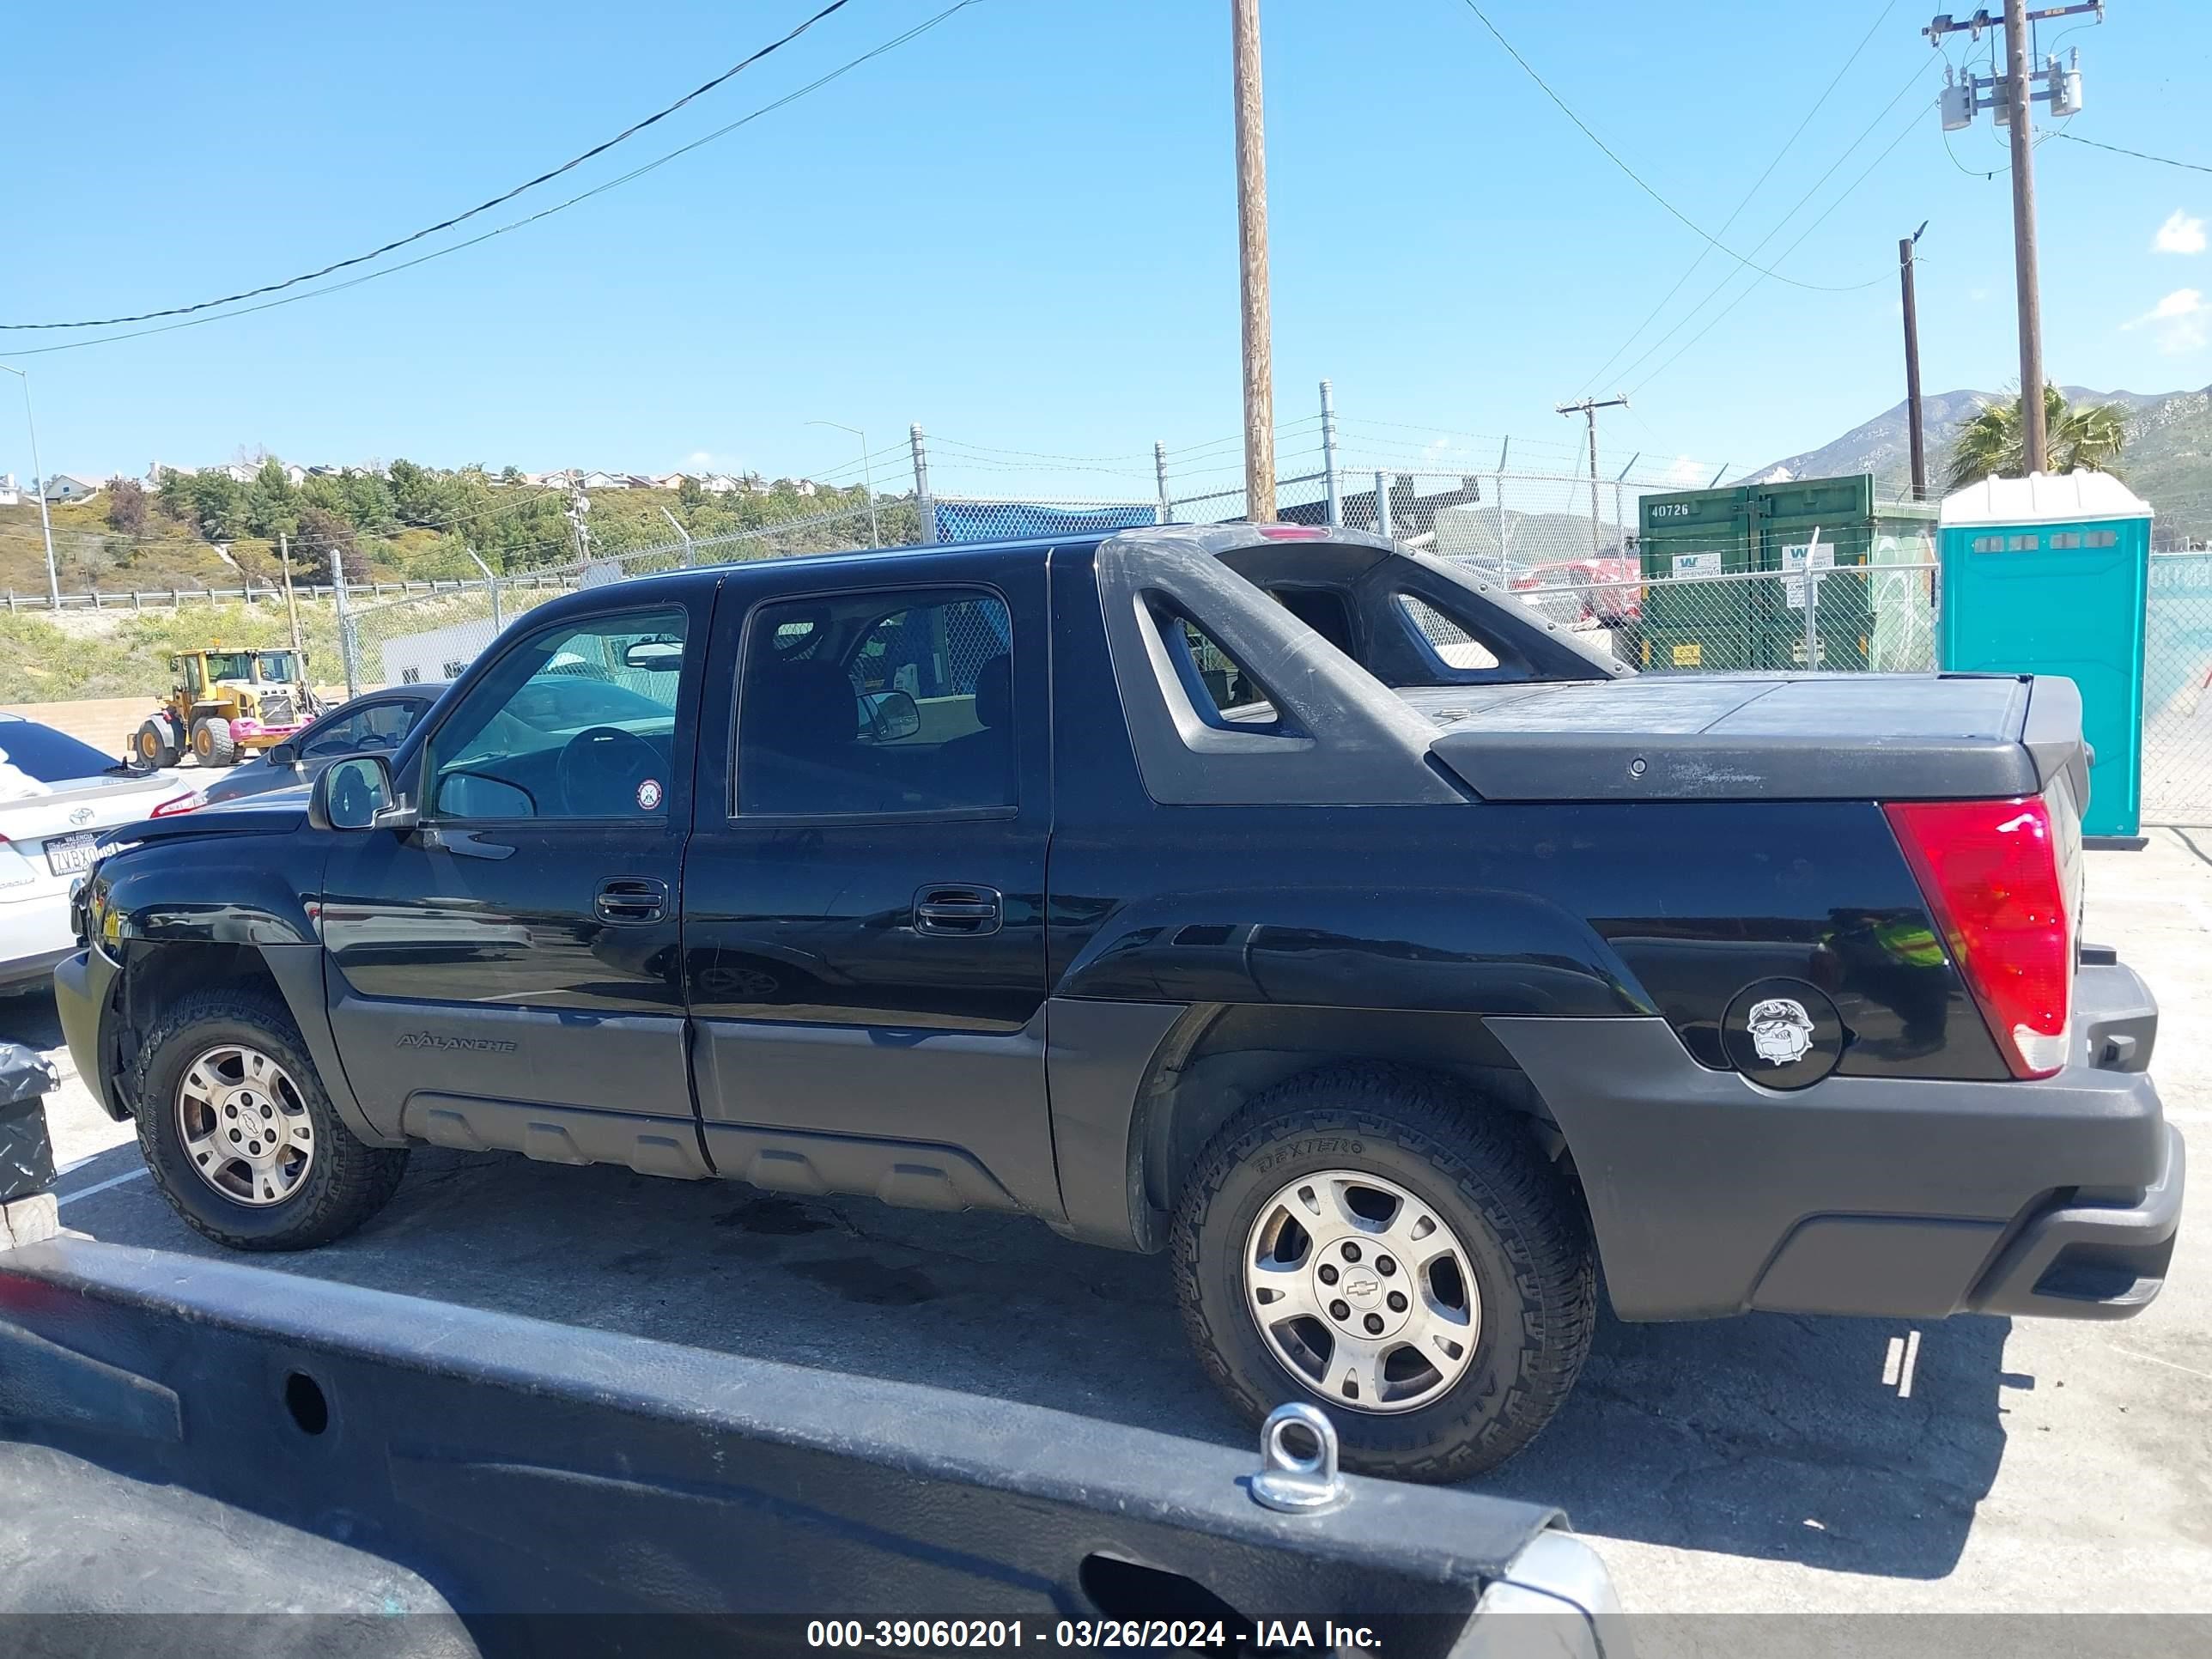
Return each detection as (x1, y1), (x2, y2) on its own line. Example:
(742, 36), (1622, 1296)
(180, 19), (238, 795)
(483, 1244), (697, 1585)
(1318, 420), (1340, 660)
(0, 0), (2212, 495)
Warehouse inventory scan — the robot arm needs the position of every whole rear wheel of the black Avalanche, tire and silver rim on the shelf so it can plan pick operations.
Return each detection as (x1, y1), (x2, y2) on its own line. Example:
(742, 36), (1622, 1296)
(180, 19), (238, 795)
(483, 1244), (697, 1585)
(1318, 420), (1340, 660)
(1170, 1066), (1597, 1482)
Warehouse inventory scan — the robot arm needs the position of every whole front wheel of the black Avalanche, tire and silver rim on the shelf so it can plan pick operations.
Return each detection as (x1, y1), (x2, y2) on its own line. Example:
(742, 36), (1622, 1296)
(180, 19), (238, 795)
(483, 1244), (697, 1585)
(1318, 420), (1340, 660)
(131, 988), (407, 1249)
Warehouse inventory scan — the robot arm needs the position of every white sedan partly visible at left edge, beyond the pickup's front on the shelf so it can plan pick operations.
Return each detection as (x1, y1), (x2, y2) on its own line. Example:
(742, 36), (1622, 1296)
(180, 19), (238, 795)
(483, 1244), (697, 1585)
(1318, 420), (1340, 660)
(0, 714), (192, 995)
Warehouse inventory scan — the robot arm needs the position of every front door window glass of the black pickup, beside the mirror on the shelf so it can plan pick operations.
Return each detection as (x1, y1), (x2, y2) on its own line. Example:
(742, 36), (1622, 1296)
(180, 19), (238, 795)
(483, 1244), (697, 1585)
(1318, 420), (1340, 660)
(422, 611), (686, 818)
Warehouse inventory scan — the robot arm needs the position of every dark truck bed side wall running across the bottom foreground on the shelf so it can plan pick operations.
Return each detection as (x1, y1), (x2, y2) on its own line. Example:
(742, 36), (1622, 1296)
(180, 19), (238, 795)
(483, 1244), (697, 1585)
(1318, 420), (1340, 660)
(0, 1239), (1608, 1652)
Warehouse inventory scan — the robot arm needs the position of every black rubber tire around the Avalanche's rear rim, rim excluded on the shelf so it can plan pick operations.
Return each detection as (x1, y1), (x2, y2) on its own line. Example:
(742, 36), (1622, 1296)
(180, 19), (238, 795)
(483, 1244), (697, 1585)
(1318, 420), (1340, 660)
(1168, 1064), (1597, 1482)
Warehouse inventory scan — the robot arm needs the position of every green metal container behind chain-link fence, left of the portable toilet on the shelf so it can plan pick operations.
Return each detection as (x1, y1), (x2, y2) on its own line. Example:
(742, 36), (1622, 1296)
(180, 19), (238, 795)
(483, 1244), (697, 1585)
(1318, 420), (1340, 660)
(1637, 473), (1936, 672)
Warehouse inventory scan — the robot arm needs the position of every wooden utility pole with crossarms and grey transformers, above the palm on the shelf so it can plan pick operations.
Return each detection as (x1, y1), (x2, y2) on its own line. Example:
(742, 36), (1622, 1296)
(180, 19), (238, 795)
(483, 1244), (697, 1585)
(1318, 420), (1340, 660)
(1920, 0), (2104, 473)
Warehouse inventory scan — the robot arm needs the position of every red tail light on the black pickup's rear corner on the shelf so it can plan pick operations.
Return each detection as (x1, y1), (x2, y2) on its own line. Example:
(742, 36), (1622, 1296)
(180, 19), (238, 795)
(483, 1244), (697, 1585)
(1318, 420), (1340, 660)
(1882, 796), (2075, 1078)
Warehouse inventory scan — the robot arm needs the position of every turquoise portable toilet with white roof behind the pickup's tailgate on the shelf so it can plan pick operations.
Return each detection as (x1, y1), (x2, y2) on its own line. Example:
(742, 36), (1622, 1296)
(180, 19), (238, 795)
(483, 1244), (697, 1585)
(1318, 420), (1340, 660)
(1938, 471), (2150, 836)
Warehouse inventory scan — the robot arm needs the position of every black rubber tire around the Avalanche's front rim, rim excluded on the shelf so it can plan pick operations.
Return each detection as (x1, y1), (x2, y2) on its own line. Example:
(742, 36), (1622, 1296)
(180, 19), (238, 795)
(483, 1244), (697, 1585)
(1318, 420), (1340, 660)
(131, 987), (407, 1249)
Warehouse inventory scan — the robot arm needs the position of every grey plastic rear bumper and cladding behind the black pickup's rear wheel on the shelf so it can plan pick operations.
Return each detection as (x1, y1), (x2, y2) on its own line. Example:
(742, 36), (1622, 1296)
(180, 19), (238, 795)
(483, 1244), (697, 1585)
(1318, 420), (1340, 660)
(1489, 960), (2185, 1318)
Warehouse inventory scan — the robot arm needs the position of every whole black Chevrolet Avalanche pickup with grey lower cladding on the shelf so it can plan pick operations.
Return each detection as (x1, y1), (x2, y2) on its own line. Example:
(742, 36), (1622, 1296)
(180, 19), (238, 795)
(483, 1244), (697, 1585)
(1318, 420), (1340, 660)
(58, 525), (2184, 1480)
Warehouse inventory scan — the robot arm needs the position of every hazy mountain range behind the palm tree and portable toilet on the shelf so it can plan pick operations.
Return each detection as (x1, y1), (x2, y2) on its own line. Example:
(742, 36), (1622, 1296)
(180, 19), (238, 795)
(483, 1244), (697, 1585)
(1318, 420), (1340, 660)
(1736, 385), (2212, 546)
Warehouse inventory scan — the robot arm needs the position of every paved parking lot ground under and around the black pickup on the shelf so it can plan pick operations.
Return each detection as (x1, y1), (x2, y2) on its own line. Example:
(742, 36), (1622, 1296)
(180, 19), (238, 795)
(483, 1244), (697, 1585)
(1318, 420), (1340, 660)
(0, 830), (2212, 1613)
